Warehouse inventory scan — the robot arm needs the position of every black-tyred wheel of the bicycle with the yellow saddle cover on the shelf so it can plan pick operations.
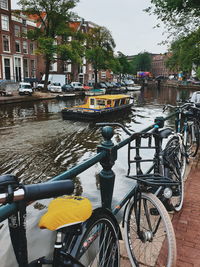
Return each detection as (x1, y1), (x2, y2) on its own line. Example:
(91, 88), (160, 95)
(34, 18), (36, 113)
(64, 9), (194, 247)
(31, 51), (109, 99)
(75, 213), (120, 267)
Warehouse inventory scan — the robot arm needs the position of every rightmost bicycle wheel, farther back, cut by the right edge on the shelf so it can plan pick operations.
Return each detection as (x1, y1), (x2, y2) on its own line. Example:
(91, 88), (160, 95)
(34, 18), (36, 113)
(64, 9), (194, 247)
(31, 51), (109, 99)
(185, 121), (200, 157)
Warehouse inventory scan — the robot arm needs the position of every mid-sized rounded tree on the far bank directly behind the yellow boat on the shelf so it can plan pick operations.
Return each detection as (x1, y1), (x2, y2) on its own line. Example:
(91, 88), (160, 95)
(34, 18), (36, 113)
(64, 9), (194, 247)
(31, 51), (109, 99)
(85, 27), (115, 86)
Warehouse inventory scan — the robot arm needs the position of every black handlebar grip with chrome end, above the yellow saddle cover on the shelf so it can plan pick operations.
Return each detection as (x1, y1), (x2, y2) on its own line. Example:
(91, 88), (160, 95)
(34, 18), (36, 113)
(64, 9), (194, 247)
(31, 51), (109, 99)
(0, 180), (74, 204)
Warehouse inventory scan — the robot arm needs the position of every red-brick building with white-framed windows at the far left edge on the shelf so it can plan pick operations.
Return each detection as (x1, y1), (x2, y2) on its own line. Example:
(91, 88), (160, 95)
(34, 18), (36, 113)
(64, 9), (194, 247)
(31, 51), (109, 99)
(0, 0), (37, 82)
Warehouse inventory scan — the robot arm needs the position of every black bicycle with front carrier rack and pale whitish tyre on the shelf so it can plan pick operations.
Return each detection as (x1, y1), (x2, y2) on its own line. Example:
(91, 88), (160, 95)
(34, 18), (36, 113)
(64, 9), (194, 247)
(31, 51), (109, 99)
(97, 121), (179, 266)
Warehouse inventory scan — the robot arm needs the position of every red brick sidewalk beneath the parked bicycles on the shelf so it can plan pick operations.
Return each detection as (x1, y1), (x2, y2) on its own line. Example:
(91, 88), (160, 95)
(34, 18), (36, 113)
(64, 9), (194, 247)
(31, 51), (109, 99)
(120, 153), (200, 267)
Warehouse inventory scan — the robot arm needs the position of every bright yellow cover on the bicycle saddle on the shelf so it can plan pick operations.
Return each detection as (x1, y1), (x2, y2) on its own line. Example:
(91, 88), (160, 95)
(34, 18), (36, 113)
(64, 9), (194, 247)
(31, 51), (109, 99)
(39, 196), (92, 231)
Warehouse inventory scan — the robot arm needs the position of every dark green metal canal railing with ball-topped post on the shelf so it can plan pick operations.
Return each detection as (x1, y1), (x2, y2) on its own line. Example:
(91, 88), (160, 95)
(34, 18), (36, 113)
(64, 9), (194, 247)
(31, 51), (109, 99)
(0, 112), (176, 222)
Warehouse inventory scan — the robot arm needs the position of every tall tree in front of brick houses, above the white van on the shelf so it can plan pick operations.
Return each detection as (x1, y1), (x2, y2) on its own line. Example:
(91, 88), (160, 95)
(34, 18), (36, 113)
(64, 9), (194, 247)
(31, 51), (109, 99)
(19, 0), (82, 89)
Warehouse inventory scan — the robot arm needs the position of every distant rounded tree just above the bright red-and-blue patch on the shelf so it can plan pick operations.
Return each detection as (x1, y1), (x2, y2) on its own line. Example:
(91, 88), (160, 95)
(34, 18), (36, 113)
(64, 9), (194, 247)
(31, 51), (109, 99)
(131, 52), (151, 74)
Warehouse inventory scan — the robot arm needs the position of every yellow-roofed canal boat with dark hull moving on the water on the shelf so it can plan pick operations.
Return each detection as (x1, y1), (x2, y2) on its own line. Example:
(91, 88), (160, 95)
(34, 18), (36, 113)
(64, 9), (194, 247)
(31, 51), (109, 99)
(62, 94), (133, 121)
